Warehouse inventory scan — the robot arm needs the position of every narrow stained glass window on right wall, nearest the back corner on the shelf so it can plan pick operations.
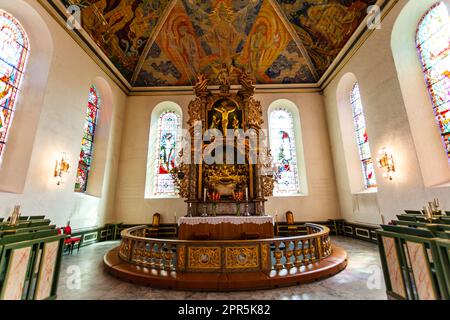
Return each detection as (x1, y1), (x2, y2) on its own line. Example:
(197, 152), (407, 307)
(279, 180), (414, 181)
(350, 82), (377, 189)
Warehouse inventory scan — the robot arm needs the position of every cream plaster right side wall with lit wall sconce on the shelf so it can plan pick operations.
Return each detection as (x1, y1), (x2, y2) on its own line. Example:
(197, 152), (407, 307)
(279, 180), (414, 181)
(324, 0), (450, 223)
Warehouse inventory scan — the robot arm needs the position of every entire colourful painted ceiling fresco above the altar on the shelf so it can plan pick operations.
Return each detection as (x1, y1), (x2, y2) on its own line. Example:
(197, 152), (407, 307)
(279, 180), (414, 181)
(60, 0), (376, 87)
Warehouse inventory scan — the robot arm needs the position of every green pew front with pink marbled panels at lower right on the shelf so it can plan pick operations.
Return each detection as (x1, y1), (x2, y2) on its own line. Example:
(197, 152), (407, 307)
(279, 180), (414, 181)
(377, 222), (449, 300)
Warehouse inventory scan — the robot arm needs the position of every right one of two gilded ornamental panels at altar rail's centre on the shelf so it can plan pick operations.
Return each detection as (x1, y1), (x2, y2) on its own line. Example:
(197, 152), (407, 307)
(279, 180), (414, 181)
(225, 245), (259, 269)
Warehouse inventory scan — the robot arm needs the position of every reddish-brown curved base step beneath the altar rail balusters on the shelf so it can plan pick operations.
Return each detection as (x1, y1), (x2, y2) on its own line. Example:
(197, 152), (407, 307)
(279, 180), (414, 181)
(104, 246), (347, 291)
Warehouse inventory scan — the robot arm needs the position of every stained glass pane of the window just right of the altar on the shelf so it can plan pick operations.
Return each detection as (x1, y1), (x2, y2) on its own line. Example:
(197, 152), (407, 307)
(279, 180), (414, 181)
(270, 108), (300, 195)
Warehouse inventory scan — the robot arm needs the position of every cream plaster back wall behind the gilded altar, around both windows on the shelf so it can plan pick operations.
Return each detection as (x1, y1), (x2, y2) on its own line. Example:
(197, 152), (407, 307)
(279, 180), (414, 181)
(115, 93), (339, 223)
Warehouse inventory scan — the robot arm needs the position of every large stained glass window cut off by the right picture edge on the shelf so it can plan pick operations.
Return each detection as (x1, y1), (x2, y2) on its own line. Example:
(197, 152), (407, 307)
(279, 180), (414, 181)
(416, 2), (450, 160)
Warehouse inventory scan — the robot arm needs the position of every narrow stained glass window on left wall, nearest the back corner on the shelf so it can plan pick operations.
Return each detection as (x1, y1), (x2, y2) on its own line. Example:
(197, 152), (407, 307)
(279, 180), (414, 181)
(75, 86), (100, 192)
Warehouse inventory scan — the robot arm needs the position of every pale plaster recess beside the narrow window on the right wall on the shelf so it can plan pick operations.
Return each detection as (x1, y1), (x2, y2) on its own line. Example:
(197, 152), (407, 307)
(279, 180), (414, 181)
(336, 72), (377, 194)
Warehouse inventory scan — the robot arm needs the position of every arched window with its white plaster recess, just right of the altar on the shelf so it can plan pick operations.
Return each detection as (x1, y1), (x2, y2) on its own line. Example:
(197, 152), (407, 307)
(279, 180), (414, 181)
(267, 99), (308, 197)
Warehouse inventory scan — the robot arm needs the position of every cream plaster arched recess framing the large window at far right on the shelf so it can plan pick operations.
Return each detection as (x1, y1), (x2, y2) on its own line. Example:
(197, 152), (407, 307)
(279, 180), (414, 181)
(391, 0), (450, 187)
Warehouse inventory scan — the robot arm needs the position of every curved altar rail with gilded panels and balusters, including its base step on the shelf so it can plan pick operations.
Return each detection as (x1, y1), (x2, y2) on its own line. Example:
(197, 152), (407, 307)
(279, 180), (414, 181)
(104, 224), (347, 291)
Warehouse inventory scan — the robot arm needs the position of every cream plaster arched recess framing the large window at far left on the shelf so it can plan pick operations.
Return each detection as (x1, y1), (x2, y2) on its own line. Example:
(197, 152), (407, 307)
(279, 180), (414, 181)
(0, 0), (54, 193)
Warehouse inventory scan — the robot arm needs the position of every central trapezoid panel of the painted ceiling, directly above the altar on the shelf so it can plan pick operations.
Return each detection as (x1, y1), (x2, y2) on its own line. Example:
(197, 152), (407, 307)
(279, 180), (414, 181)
(133, 0), (315, 87)
